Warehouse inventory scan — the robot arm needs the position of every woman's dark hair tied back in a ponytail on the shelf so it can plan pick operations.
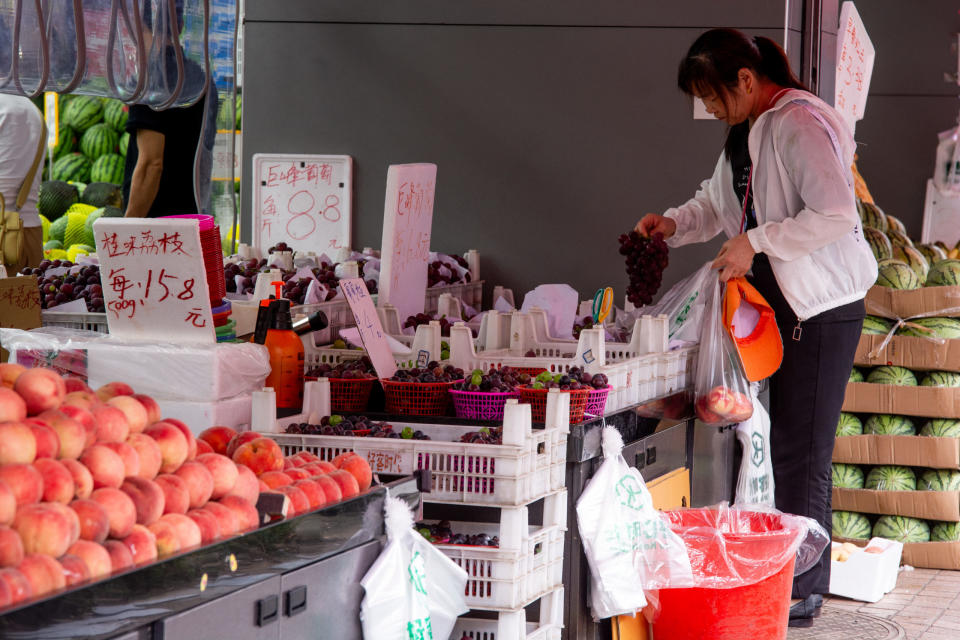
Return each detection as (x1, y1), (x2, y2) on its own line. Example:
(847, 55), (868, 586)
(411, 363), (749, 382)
(677, 29), (808, 158)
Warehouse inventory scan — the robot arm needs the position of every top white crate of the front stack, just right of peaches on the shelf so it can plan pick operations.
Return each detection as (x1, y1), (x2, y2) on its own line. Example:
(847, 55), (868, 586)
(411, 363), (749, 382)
(266, 391), (570, 507)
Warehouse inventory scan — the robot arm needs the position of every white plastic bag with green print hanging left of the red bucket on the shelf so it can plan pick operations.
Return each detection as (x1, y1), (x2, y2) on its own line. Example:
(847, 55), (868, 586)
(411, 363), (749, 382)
(577, 427), (693, 620)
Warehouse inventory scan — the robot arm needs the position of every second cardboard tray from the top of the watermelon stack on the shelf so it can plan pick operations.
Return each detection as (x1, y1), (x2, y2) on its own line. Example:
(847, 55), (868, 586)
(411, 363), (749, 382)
(853, 335), (960, 371)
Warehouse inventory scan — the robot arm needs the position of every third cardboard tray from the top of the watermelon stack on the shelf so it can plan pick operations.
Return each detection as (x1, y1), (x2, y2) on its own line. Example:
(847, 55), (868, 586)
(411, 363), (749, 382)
(843, 382), (960, 418)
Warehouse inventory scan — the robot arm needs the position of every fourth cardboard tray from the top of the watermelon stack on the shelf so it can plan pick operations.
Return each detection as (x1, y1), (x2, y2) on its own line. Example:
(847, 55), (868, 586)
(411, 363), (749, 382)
(833, 435), (960, 469)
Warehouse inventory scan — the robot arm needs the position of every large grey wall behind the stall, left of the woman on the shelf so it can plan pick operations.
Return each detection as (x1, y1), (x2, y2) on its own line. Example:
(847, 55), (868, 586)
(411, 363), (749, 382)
(243, 0), (802, 301)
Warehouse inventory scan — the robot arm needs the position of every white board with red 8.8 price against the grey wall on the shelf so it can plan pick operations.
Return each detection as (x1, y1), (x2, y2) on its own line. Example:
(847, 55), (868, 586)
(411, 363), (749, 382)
(253, 153), (353, 255)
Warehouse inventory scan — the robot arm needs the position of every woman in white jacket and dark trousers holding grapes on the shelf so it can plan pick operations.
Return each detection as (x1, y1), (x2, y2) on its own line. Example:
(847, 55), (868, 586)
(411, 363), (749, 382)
(637, 29), (877, 626)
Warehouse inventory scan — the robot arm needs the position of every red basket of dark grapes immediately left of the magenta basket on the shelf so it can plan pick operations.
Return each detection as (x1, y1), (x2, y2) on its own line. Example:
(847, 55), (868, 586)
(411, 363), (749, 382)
(380, 362), (463, 416)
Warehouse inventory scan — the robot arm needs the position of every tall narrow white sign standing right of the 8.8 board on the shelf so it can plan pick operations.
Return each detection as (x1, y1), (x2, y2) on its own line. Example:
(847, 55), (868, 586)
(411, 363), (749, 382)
(378, 164), (437, 318)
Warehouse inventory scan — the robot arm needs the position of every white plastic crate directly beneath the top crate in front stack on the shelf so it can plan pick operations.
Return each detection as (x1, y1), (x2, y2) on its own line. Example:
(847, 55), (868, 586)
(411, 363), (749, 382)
(424, 491), (567, 611)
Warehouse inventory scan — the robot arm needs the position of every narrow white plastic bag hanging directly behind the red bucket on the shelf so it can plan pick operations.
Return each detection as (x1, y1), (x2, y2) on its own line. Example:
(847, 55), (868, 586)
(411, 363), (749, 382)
(736, 382), (774, 507)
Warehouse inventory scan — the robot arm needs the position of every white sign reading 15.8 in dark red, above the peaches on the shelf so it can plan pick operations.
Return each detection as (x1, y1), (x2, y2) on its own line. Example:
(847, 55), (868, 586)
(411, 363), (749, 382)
(93, 218), (216, 343)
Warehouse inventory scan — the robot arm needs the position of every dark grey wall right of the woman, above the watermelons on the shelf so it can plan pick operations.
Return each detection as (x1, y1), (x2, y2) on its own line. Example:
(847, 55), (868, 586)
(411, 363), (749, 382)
(856, 0), (960, 240)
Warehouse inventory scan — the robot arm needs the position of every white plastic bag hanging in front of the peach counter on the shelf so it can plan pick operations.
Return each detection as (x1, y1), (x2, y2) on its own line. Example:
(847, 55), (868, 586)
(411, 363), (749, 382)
(360, 497), (469, 640)
